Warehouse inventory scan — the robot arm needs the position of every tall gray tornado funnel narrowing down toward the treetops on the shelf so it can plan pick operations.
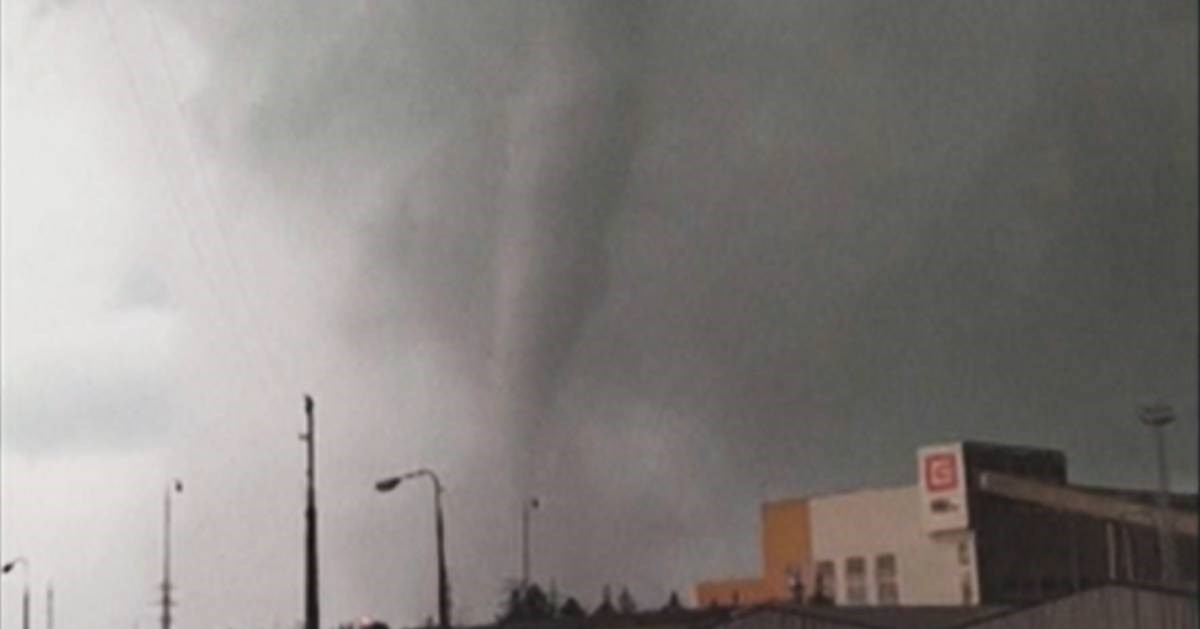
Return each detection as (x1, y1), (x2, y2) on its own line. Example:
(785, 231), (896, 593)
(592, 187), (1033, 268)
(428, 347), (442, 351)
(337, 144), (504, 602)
(493, 2), (647, 490)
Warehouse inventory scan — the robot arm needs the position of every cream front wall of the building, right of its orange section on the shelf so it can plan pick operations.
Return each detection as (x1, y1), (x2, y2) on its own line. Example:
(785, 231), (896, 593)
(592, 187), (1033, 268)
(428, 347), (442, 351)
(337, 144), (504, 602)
(809, 485), (979, 605)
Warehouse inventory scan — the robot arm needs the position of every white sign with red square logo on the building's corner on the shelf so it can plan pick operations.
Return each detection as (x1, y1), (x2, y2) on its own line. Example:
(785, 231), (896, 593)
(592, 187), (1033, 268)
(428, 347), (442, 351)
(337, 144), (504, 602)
(917, 443), (967, 533)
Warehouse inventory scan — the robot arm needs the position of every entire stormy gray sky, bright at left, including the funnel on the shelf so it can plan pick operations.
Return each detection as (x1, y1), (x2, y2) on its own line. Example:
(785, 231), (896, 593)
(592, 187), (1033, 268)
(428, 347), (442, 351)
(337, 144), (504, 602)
(0, 0), (1198, 629)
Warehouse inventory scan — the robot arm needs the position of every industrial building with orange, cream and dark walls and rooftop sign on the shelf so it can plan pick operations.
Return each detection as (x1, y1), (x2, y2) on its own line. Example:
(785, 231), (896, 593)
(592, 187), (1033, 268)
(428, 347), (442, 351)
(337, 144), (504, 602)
(695, 442), (1196, 606)
